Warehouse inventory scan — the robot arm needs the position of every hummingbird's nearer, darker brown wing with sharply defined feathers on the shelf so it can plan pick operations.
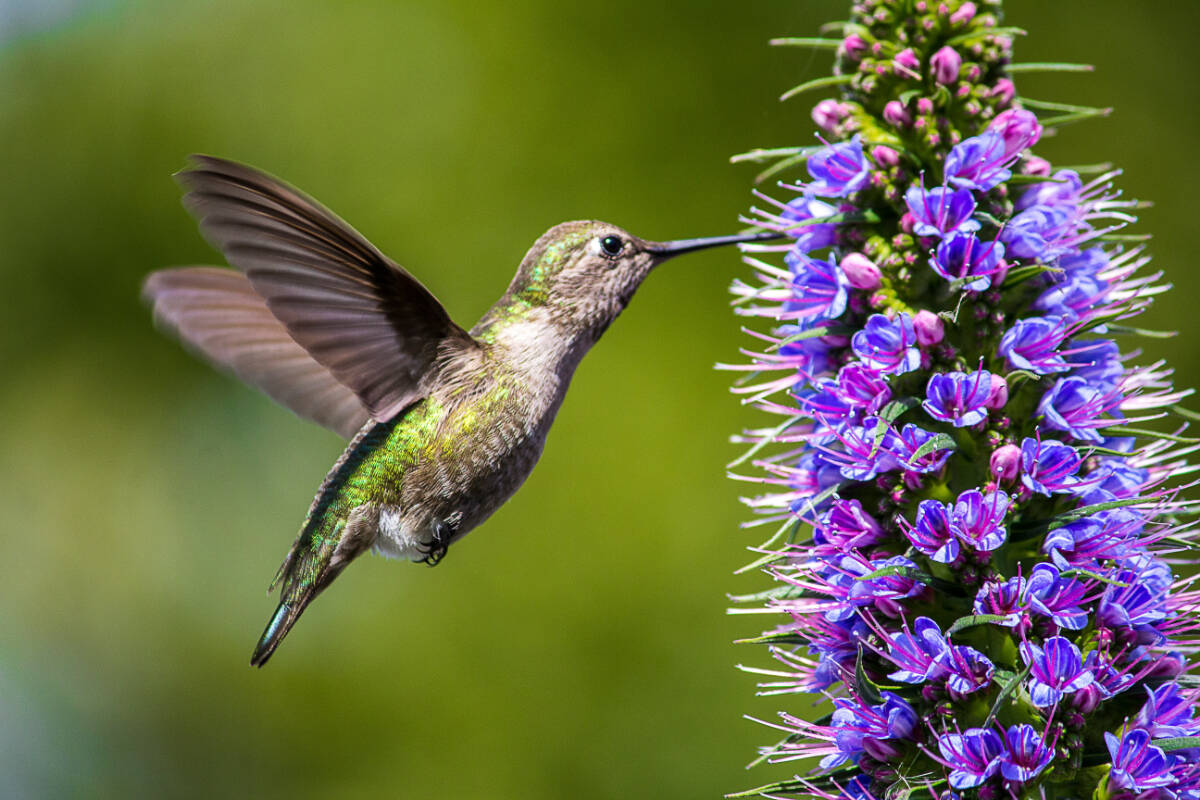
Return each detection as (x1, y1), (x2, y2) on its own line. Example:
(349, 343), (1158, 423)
(178, 156), (479, 422)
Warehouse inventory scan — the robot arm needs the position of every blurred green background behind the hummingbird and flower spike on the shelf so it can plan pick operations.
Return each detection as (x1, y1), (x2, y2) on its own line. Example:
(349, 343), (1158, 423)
(0, 0), (1200, 798)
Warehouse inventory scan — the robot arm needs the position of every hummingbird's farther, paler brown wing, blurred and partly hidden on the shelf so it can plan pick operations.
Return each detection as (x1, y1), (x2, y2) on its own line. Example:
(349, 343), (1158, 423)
(142, 266), (368, 439)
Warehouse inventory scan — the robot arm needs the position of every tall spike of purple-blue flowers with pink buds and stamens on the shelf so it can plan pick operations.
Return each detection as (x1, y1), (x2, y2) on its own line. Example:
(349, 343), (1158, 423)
(733, 0), (1200, 800)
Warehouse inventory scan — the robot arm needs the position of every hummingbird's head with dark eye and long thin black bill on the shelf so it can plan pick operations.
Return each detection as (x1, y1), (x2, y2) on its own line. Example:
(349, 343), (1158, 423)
(509, 219), (779, 333)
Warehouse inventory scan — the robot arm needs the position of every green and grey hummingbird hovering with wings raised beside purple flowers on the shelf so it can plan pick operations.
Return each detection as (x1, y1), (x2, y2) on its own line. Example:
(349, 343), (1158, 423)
(143, 156), (778, 667)
